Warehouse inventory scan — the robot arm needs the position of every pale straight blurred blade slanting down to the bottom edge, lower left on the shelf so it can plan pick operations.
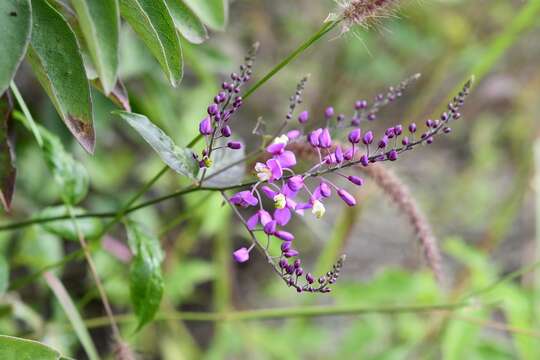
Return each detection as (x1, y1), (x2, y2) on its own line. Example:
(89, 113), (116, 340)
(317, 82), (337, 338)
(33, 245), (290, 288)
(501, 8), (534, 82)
(43, 271), (99, 360)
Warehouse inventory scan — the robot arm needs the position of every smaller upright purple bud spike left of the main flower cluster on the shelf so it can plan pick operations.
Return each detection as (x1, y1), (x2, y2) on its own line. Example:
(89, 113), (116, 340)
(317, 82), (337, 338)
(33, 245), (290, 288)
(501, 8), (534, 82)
(197, 44), (258, 168)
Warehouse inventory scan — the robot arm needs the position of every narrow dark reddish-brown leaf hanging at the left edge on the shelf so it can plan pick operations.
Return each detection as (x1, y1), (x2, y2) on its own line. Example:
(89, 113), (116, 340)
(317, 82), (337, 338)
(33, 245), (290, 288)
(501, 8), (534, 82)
(0, 93), (17, 211)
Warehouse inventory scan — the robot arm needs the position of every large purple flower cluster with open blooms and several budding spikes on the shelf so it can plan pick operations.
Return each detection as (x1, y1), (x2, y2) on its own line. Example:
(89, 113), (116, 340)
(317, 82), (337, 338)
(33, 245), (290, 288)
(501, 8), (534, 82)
(217, 64), (471, 293)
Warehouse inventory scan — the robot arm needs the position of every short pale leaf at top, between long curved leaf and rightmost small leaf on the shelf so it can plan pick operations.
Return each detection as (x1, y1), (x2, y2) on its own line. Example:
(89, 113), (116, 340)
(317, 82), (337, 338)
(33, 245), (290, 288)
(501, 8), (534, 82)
(166, 0), (208, 44)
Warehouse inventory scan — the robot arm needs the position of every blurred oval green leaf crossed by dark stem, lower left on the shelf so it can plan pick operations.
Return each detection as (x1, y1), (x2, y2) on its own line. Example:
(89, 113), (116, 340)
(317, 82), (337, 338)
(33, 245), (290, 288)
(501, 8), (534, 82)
(38, 205), (103, 240)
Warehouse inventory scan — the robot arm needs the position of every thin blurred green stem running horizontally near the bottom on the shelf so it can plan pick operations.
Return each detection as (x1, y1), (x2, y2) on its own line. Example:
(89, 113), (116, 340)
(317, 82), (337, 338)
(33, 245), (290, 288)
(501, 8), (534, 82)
(85, 302), (480, 328)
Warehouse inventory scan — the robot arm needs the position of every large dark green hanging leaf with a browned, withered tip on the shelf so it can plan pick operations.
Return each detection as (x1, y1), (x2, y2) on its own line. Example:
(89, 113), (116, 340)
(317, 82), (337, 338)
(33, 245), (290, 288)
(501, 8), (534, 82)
(28, 0), (95, 153)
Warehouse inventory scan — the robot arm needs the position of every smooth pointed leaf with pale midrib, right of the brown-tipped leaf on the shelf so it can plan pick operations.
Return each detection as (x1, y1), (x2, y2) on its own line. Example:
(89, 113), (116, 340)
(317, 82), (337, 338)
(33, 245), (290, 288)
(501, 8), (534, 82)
(71, 0), (120, 95)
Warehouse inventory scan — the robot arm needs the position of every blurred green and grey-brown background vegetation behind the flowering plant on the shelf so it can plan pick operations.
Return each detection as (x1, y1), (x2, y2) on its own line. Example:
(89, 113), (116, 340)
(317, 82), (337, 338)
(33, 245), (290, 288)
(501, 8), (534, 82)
(0, 0), (540, 359)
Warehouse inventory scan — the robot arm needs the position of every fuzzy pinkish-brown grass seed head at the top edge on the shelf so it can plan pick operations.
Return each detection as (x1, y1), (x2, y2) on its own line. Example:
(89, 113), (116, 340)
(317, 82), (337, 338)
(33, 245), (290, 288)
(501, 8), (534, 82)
(327, 0), (399, 34)
